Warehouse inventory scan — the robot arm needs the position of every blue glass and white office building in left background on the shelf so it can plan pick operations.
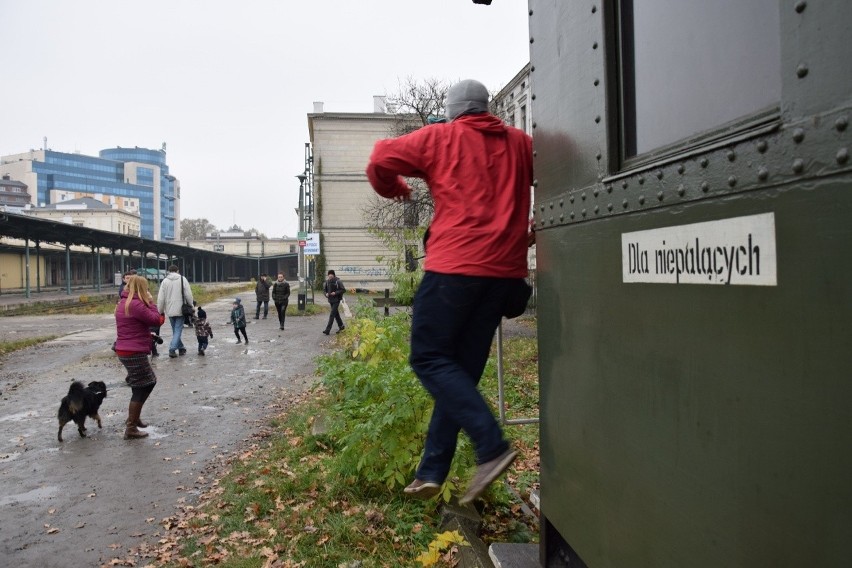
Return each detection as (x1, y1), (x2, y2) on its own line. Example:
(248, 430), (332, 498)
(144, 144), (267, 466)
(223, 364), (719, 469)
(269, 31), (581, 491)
(0, 147), (180, 240)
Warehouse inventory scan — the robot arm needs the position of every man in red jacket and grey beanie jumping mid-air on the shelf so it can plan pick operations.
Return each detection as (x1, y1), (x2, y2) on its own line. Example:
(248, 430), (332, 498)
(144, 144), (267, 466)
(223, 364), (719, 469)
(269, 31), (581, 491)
(367, 80), (532, 504)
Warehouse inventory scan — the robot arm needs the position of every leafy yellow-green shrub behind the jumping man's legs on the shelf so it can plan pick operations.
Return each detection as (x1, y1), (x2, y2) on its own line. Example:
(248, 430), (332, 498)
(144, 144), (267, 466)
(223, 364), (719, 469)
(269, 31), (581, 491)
(319, 309), (473, 499)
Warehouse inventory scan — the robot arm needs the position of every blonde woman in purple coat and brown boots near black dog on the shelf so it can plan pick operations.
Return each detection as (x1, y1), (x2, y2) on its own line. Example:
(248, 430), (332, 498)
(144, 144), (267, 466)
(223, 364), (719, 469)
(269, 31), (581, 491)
(115, 276), (163, 440)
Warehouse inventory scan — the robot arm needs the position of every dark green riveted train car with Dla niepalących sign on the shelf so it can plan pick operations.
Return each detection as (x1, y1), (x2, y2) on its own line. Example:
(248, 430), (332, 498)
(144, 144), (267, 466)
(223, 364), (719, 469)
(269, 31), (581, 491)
(529, 0), (852, 568)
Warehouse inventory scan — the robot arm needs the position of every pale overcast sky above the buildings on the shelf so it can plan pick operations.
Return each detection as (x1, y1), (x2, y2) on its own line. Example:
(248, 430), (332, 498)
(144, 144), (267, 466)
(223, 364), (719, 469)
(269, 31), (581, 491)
(0, 0), (529, 237)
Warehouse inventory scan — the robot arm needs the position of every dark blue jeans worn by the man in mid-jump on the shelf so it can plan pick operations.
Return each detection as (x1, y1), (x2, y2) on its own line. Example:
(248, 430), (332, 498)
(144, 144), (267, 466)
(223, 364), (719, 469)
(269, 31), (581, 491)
(410, 272), (512, 483)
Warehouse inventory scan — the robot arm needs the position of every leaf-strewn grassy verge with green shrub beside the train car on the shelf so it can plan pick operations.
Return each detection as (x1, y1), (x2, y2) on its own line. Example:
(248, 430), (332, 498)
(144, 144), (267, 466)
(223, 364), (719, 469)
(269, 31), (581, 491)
(125, 313), (538, 568)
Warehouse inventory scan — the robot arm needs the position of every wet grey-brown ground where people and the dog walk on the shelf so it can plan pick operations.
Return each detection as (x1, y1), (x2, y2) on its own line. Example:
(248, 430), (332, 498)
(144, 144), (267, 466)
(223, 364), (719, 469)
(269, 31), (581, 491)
(0, 298), (331, 568)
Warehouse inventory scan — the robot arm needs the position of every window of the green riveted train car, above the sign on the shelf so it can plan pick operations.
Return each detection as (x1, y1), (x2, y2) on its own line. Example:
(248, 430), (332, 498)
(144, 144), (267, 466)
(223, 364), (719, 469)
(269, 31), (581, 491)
(618, 0), (781, 159)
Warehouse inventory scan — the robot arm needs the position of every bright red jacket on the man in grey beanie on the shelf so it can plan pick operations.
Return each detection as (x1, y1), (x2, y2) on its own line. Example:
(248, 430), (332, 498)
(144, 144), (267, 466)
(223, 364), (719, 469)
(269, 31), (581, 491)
(367, 113), (533, 278)
